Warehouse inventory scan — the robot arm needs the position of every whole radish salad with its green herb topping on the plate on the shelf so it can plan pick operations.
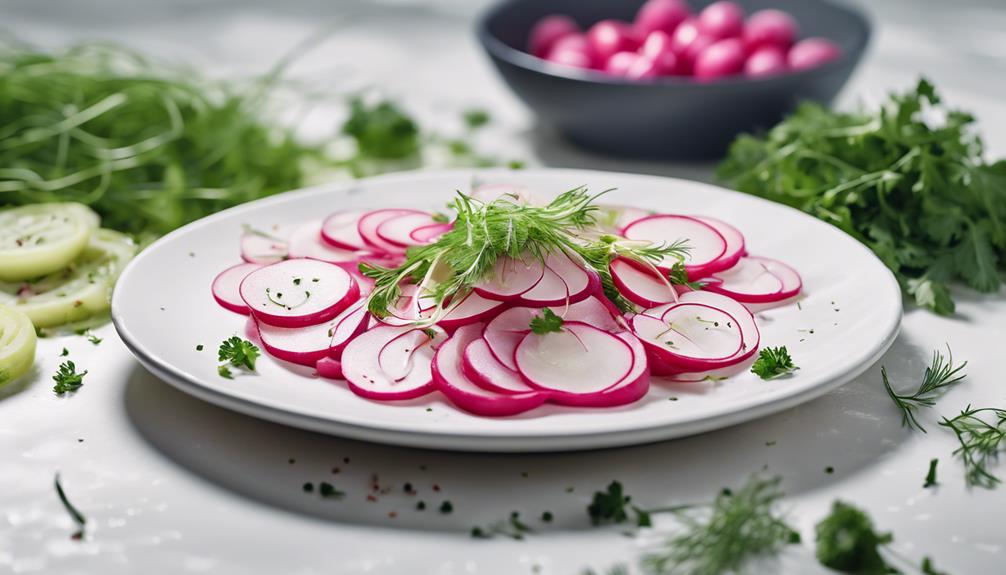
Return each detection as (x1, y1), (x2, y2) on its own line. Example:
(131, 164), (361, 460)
(211, 185), (802, 416)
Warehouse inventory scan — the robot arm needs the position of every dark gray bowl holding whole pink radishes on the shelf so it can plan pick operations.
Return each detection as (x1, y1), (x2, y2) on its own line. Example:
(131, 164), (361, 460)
(478, 0), (870, 160)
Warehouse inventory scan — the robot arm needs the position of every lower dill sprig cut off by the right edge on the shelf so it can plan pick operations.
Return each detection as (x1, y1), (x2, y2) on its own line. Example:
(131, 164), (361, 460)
(940, 405), (1006, 489)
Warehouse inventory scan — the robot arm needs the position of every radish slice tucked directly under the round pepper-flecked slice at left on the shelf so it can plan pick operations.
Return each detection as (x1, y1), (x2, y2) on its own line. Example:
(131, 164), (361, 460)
(258, 301), (369, 366)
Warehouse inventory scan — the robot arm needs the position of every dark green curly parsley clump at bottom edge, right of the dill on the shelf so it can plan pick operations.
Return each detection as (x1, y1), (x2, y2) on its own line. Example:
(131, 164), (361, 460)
(816, 501), (897, 574)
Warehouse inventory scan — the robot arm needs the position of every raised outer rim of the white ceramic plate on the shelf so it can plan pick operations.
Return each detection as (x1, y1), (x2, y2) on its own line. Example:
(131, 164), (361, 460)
(111, 168), (903, 452)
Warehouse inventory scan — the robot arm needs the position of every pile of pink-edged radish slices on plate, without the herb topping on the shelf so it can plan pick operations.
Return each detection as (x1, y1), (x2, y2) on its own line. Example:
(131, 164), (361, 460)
(212, 193), (802, 416)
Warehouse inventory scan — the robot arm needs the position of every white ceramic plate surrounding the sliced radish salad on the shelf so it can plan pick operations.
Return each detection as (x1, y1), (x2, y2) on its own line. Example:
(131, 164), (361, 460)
(112, 170), (901, 451)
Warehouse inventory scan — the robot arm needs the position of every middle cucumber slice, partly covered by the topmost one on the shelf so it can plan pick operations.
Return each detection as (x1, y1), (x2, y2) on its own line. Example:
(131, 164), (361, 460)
(0, 229), (136, 328)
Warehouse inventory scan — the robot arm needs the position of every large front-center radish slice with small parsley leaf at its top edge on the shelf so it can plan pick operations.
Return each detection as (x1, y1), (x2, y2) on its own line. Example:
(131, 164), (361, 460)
(514, 322), (635, 395)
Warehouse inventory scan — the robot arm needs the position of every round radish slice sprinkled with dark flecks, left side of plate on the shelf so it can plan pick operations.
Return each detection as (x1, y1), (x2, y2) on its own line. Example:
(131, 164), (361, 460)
(240, 259), (360, 328)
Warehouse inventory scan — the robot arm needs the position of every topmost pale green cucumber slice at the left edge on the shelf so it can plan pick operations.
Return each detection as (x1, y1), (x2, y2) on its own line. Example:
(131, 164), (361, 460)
(0, 203), (99, 281)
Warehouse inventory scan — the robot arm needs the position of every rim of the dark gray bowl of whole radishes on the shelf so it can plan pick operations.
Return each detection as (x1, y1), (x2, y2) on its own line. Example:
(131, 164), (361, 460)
(476, 0), (873, 90)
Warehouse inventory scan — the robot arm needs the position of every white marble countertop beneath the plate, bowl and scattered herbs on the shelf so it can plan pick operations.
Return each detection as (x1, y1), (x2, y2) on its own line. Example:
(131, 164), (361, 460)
(0, 0), (1006, 575)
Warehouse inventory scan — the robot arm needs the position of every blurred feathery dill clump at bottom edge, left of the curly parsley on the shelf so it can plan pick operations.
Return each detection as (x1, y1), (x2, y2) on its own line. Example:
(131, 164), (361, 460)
(643, 475), (800, 575)
